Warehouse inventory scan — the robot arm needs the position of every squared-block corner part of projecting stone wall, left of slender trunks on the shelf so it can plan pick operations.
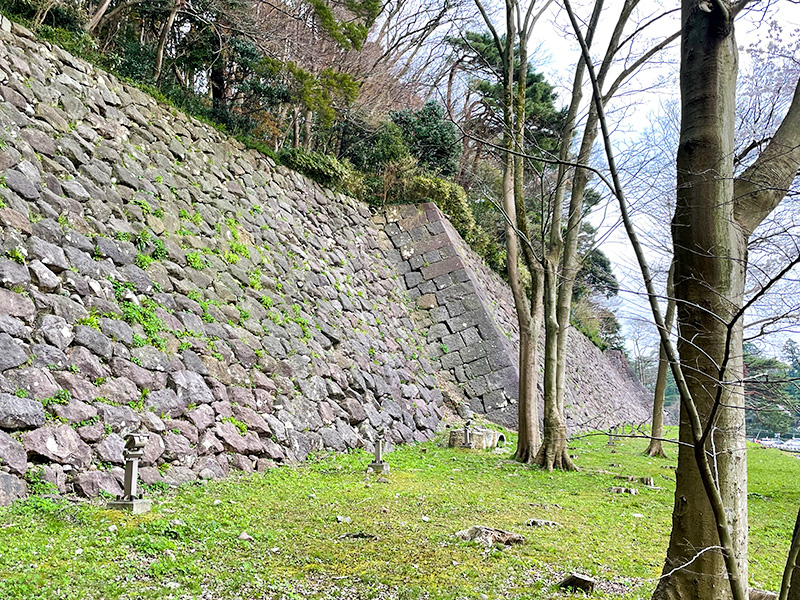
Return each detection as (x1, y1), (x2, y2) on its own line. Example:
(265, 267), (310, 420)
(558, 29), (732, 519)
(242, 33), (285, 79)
(378, 204), (519, 427)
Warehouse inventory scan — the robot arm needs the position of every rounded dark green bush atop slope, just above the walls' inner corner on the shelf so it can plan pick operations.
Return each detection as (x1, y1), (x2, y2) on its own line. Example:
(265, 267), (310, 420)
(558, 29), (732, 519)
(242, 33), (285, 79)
(389, 101), (461, 177)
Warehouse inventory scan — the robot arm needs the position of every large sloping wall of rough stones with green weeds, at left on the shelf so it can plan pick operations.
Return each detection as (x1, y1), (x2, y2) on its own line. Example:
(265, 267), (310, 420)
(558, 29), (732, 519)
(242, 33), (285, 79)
(0, 21), (442, 504)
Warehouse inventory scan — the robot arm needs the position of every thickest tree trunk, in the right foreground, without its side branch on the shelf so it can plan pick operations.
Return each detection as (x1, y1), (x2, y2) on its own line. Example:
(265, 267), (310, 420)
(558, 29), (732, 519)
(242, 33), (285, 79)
(653, 0), (747, 600)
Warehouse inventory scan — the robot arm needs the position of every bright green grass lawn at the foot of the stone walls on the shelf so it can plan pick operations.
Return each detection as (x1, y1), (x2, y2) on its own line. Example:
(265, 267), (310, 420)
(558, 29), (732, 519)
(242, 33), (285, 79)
(0, 424), (800, 600)
